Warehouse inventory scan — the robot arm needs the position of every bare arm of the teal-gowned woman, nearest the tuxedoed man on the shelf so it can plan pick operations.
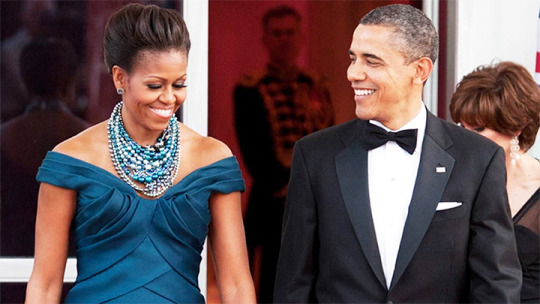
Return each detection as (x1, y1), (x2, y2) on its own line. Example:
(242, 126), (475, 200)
(208, 192), (256, 304)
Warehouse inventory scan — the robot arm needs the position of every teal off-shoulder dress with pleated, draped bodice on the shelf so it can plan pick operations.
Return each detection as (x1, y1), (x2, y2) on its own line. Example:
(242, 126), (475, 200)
(37, 152), (245, 303)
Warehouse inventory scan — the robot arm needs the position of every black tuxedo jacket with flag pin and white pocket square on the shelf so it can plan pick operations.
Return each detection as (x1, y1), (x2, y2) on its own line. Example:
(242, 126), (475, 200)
(274, 112), (521, 303)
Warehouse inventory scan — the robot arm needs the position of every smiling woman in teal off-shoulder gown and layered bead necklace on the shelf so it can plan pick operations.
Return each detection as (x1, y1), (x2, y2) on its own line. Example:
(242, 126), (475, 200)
(26, 4), (255, 303)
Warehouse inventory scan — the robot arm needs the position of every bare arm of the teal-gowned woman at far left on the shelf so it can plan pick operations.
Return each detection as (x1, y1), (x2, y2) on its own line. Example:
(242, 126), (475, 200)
(26, 183), (77, 303)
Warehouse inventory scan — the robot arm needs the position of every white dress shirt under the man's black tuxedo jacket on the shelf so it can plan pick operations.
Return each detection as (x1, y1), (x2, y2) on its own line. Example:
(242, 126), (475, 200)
(368, 105), (427, 288)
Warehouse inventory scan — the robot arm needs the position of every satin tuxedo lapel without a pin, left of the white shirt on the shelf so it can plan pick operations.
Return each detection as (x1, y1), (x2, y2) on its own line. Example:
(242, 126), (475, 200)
(335, 139), (386, 288)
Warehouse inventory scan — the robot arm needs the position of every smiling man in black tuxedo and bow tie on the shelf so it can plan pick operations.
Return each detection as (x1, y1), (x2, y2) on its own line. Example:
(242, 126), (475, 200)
(274, 5), (521, 303)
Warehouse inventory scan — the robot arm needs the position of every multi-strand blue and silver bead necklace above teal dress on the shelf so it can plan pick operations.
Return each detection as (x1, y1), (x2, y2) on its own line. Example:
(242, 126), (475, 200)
(107, 102), (180, 197)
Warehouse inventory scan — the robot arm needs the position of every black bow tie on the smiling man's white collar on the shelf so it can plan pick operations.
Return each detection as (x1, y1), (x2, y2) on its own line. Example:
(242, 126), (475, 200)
(364, 122), (418, 154)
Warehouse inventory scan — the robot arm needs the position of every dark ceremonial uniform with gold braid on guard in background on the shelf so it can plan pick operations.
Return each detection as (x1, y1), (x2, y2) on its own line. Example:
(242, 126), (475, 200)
(234, 65), (334, 301)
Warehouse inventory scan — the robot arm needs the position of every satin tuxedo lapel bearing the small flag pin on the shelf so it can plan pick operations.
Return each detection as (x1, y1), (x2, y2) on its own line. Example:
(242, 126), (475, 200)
(390, 114), (454, 289)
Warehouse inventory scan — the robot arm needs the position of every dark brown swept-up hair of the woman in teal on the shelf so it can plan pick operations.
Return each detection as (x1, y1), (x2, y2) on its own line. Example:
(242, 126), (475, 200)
(103, 3), (191, 73)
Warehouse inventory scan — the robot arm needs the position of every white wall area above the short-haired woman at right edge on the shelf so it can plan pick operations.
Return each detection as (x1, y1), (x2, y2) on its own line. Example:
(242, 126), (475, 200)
(454, 0), (540, 158)
